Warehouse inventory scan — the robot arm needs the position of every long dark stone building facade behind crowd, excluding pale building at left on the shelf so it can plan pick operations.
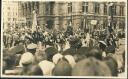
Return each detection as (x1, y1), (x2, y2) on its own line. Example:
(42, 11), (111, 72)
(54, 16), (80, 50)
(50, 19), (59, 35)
(16, 1), (126, 30)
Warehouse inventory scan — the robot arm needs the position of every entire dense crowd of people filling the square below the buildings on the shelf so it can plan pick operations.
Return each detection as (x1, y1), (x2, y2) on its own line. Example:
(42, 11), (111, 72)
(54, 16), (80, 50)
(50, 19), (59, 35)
(2, 26), (125, 76)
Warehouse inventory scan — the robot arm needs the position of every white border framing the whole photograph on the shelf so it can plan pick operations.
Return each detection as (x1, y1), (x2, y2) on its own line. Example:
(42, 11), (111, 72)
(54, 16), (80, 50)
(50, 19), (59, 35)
(0, 0), (127, 79)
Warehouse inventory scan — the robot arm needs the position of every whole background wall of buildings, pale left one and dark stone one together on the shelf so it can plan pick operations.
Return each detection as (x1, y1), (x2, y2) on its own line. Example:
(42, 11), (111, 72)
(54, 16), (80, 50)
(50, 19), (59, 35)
(3, 1), (126, 30)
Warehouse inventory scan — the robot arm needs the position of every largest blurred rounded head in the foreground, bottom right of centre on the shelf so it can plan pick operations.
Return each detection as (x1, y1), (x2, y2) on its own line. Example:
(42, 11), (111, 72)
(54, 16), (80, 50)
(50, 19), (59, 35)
(72, 57), (111, 76)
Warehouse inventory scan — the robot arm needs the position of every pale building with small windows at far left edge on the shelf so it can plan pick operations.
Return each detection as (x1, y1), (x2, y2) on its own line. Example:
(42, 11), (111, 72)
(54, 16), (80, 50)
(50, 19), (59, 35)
(2, 1), (21, 29)
